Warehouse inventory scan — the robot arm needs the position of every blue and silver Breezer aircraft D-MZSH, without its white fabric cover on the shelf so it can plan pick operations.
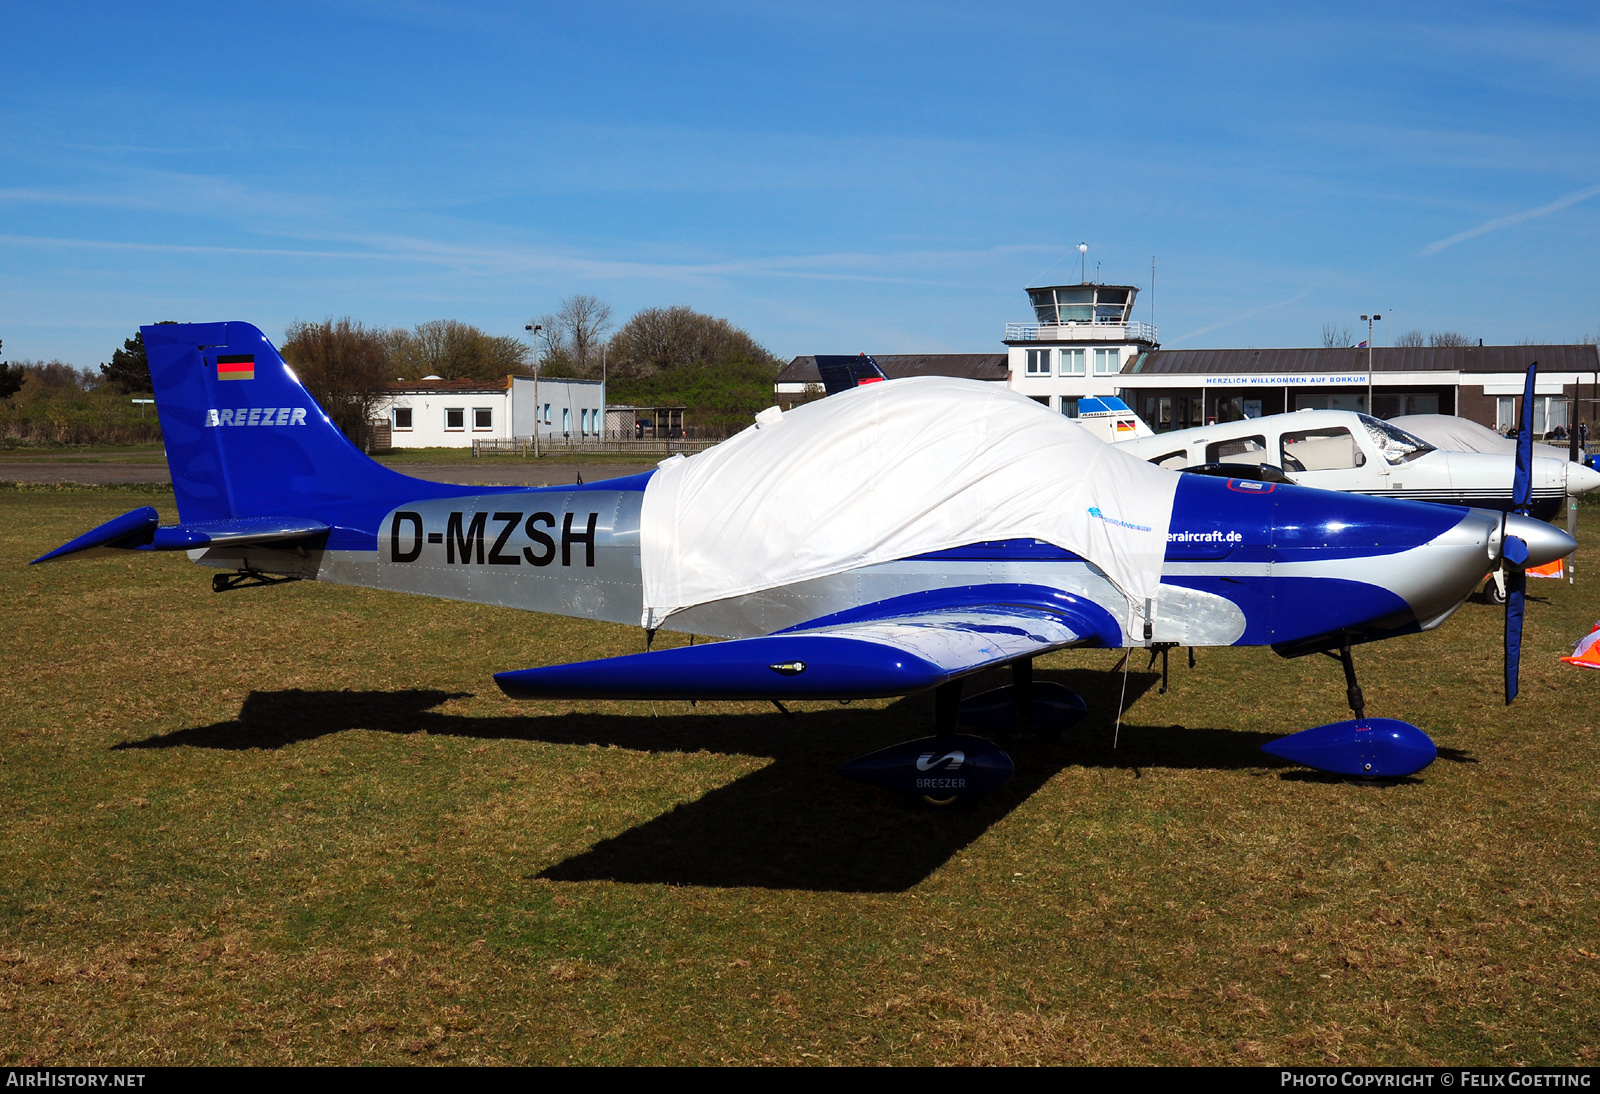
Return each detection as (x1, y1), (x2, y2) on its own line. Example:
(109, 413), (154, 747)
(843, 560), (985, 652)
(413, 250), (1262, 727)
(35, 323), (1576, 800)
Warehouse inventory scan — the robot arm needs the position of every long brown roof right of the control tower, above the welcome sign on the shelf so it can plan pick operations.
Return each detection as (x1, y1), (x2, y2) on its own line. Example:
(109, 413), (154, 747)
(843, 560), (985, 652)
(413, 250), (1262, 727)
(1126, 345), (1600, 376)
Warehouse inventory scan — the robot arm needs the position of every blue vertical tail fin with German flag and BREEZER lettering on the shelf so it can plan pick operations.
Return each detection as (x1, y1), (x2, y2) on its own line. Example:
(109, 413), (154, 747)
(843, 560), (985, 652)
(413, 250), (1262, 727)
(139, 321), (418, 525)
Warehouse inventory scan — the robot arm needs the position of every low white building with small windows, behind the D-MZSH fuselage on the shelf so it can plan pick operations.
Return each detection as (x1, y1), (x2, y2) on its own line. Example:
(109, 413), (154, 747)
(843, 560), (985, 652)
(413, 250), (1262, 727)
(376, 376), (605, 448)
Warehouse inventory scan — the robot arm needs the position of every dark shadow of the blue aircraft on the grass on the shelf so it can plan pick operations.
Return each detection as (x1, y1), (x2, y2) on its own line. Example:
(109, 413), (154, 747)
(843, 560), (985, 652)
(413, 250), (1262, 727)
(106, 670), (1465, 892)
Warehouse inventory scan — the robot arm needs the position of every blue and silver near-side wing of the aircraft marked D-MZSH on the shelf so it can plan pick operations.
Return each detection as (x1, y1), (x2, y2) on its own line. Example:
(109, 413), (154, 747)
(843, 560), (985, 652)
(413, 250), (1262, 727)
(494, 589), (1120, 699)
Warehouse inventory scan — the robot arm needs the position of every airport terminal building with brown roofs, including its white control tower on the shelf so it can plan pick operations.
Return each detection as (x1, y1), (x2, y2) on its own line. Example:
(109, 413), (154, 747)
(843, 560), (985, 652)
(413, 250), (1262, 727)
(774, 281), (1600, 433)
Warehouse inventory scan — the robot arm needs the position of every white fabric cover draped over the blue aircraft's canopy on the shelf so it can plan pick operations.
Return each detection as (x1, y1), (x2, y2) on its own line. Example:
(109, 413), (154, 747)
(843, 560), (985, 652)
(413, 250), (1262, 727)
(640, 376), (1178, 629)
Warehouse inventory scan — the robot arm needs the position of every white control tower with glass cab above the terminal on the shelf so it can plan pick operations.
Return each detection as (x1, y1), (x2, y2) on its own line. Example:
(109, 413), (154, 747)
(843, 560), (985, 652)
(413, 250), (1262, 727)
(1005, 281), (1157, 417)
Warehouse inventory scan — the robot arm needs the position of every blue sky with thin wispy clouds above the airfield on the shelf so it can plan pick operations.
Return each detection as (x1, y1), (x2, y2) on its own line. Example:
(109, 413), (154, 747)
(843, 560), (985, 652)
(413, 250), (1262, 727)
(0, 0), (1600, 365)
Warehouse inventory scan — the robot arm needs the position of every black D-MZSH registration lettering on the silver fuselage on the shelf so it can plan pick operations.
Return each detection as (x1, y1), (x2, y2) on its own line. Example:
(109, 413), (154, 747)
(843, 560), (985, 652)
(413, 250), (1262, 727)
(389, 510), (600, 566)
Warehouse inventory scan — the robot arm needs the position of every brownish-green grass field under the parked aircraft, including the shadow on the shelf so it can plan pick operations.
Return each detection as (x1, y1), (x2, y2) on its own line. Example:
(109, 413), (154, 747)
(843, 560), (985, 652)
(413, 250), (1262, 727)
(0, 489), (1600, 1065)
